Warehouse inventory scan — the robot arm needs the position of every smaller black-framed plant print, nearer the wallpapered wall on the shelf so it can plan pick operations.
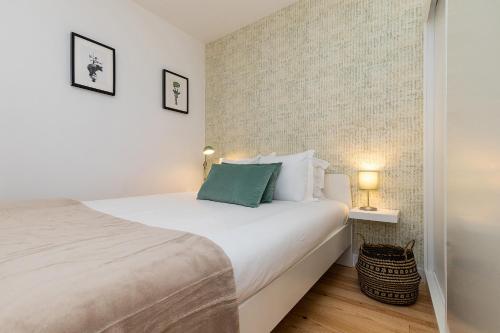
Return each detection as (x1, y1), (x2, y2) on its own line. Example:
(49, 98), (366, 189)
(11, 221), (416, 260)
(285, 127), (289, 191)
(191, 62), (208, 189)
(163, 69), (189, 114)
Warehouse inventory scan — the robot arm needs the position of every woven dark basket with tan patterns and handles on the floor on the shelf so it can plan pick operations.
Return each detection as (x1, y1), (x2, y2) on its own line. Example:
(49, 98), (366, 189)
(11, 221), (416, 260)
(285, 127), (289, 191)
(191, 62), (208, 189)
(356, 236), (421, 305)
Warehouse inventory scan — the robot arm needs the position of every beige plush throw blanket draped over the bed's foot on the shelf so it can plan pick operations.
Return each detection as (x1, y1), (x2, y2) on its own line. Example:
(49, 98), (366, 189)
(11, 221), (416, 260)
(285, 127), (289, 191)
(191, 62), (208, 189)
(0, 200), (238, 333)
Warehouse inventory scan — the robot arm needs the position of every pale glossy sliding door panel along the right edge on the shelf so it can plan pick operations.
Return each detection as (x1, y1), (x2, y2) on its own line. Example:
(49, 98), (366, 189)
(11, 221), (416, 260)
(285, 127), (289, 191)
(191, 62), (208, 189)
(446, 0), (500, 333)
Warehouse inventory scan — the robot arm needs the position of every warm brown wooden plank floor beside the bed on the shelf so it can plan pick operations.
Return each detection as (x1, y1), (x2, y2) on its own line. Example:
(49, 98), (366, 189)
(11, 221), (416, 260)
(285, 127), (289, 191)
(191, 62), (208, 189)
(273, 265), (438, 333)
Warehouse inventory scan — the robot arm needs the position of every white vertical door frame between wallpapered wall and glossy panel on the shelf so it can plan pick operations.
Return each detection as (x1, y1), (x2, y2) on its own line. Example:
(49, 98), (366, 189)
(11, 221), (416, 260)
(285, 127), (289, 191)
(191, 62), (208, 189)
(423, 0), (448, 333)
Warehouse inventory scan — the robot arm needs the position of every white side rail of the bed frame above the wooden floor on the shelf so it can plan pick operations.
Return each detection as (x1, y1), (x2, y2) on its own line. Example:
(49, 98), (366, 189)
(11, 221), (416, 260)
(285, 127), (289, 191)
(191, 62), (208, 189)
(239, 220), (353, 333)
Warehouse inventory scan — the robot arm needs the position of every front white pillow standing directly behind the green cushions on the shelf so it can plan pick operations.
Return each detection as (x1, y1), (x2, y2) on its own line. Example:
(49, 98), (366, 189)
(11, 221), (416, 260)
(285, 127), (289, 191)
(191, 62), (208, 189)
(259, 150), (314, 201)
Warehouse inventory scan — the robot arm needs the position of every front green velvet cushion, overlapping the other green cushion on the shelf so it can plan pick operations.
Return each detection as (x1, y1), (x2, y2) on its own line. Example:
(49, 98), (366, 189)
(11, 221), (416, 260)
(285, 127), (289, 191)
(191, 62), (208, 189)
(198, 163), (276, 207)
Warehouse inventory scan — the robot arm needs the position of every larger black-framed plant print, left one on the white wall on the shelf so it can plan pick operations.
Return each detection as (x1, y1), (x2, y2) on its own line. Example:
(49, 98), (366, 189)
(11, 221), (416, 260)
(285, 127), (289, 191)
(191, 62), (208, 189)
(71, 32), (116, 96)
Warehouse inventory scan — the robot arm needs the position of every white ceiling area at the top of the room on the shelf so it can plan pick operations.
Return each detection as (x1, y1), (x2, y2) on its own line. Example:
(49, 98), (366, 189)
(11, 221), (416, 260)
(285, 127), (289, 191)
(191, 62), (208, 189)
(135, 0), (297, 42)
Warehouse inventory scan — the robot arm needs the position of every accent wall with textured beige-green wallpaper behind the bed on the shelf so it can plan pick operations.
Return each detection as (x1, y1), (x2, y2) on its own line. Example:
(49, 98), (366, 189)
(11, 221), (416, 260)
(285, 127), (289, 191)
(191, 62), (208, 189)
(206, 0), (427, 266)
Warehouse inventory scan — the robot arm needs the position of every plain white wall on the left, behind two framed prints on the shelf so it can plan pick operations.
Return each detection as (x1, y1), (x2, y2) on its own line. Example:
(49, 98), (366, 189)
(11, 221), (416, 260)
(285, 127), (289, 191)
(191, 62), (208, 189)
(0, 0), (205, 200)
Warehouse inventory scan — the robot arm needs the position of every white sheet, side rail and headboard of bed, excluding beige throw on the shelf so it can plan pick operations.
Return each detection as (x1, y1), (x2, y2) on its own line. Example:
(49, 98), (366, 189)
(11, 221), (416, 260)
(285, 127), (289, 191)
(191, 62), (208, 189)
(84, 175), (351, 332)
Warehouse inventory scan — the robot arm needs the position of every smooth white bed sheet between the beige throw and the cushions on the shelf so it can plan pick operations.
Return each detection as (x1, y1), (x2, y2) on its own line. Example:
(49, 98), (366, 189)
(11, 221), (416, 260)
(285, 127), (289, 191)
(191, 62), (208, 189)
(84, 193), (349, 303)
